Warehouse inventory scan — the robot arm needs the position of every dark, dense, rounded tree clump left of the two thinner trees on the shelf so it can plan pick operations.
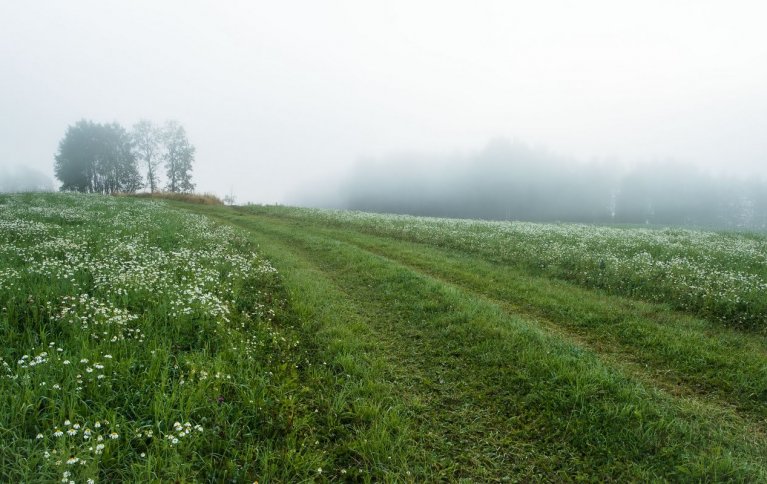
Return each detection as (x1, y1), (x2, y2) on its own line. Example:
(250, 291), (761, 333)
(55, 120), (142, 194)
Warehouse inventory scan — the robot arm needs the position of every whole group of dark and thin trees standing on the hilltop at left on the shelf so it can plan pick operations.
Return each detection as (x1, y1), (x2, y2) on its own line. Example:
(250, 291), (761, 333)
(54, 120), (195, 194)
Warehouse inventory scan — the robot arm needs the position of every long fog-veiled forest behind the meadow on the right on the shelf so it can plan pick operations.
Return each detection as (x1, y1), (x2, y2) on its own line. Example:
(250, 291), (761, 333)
(301, 141), (767, 230)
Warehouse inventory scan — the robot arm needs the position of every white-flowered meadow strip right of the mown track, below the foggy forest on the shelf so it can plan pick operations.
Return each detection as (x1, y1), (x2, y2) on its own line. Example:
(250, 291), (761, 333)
(250, 206), (767, 331)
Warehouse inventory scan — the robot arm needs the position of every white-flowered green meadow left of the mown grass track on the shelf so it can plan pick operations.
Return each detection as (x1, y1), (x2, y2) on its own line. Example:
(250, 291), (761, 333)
(0, 194), (322, 483)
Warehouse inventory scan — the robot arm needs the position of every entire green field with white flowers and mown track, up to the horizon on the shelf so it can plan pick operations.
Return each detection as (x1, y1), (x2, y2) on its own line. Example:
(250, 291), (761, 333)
(0, 195), (767, 482)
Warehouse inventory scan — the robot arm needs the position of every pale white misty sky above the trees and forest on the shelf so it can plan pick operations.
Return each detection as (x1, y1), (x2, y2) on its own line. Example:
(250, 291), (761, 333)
(0, 0), (767, 203)
